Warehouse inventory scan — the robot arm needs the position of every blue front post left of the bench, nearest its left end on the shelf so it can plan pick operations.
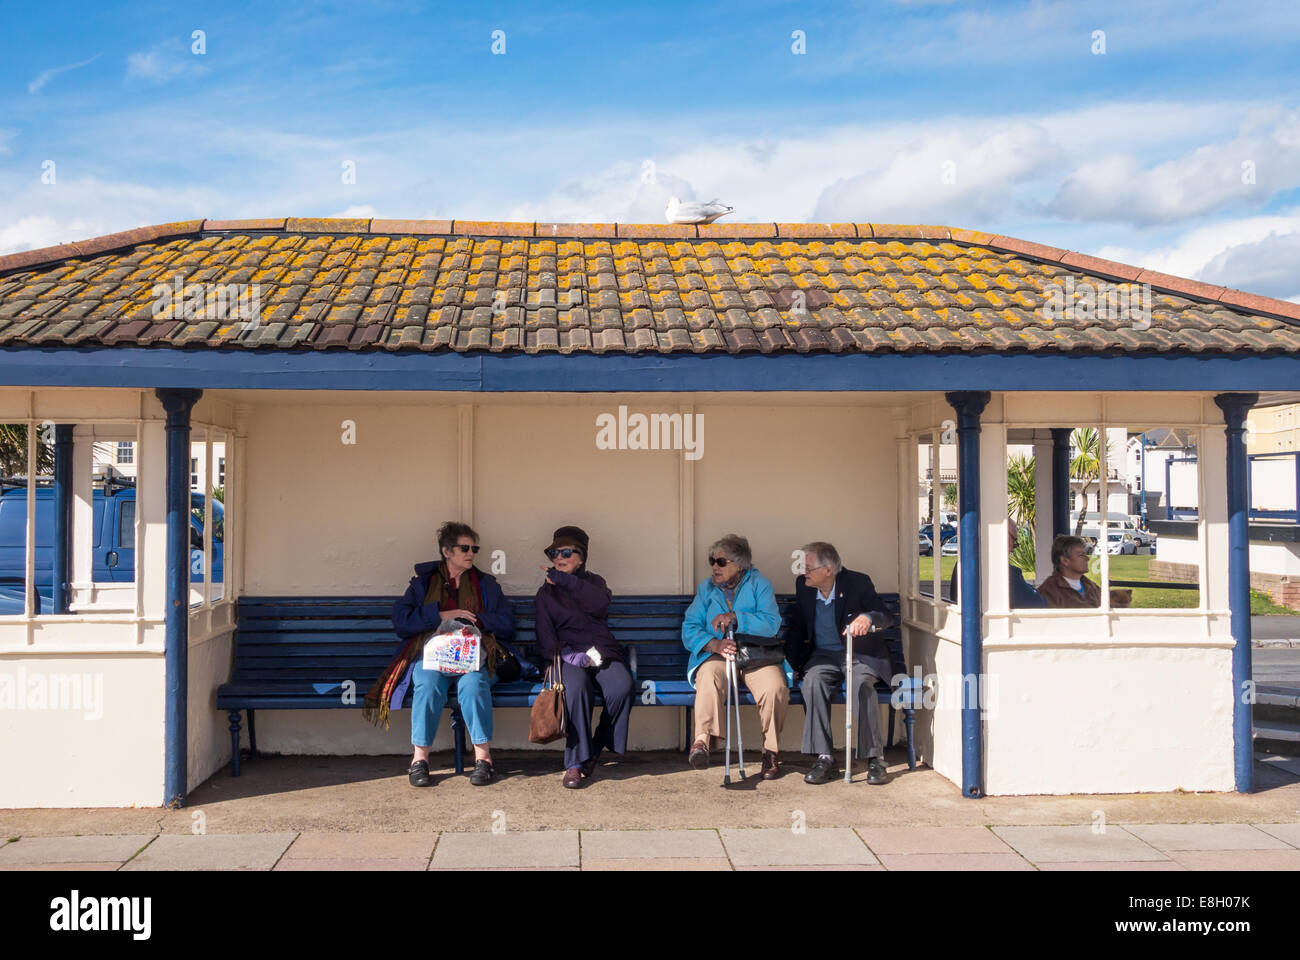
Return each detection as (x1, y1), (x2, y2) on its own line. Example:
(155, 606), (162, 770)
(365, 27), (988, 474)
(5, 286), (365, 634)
(155, 388), (203, 808)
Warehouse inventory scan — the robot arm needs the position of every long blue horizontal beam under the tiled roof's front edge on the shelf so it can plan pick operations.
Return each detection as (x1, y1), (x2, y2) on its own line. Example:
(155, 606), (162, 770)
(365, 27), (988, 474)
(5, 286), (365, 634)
(0, 346), (1300, 393)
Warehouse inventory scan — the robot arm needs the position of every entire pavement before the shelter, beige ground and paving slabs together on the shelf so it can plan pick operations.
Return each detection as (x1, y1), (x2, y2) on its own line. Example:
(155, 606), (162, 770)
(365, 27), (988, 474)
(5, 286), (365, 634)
(0, 752), (1300, 870)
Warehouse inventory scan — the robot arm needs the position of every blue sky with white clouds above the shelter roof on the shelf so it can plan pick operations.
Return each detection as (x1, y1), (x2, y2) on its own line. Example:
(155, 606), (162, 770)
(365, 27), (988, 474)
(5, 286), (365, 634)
(0, 0), (1300, 300)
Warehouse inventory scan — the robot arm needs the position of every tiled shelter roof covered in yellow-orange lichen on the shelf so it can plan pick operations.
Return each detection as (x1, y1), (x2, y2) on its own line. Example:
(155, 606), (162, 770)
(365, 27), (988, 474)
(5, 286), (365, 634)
(0, 220), (1300, 354)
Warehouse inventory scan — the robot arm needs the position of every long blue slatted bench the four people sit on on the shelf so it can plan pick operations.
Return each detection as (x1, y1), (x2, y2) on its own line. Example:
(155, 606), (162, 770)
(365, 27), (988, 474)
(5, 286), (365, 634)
(217, 593), (920, 777)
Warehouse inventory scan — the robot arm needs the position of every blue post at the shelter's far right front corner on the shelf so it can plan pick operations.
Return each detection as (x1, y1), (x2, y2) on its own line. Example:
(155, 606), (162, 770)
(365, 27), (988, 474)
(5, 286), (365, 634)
(1214, 393), (1260, 793)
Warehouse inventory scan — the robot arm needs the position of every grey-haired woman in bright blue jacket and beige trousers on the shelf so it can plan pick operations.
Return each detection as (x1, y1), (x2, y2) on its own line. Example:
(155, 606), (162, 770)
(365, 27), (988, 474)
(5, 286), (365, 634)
(681, 533), (790, 780)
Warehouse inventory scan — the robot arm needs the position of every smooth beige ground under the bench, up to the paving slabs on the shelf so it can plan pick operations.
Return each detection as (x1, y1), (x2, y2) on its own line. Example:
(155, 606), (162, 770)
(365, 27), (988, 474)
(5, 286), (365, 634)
(0, 751), (1300, 836)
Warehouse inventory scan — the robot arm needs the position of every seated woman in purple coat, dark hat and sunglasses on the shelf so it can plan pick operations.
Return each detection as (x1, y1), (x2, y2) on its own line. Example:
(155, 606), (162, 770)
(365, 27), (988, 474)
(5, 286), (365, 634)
(537, 527), (633, 790)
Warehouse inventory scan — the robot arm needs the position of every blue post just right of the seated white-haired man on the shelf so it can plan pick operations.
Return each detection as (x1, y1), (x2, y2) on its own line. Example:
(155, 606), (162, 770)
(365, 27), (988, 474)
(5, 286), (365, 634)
(944, 390), (989, 797)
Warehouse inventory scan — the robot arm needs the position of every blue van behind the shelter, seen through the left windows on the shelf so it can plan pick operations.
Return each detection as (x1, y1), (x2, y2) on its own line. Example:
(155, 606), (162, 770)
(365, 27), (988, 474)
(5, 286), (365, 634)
(0, 481), (225, 614)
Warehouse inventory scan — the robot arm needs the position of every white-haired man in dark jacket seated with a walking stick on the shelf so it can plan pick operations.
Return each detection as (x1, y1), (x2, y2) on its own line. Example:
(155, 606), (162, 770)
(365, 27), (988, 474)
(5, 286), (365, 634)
(785, 541), (893, 783)
